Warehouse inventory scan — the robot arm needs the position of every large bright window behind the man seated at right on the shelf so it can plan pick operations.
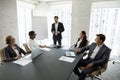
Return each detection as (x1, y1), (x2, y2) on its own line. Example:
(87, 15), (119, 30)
(89, 8), (120, 56)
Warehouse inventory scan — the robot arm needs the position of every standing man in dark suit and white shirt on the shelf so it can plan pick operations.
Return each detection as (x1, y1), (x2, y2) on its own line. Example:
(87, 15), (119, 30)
(51, 16), (64, 46)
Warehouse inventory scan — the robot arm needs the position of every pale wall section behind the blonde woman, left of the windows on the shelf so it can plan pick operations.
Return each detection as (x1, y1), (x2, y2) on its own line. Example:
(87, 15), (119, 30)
(0, 0), (18, 47)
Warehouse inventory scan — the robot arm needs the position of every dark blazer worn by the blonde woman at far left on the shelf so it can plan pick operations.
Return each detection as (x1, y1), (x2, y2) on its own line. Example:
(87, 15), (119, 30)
(4, 44), (26, 62)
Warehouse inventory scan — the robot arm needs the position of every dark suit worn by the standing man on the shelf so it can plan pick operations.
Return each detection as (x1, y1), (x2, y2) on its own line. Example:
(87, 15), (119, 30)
(51, 22), (64, 45)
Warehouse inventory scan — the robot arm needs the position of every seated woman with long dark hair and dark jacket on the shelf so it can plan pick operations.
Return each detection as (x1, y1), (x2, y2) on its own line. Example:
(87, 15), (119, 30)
(70, 31), (88, 51)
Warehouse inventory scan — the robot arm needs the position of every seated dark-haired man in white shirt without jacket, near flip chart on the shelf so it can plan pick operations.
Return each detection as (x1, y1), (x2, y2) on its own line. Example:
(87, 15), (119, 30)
(28, 31), (46, 50)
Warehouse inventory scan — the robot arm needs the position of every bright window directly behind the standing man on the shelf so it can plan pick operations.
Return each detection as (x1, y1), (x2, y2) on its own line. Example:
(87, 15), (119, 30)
(48, 1), (72, 46)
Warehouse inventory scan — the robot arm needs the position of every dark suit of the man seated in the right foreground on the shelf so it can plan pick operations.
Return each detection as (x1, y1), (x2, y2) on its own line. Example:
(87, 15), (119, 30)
(74, 43), (110, 80)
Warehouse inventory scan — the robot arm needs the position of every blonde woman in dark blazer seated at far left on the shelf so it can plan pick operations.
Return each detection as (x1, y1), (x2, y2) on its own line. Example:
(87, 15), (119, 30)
(5, 35), (26, 62)
